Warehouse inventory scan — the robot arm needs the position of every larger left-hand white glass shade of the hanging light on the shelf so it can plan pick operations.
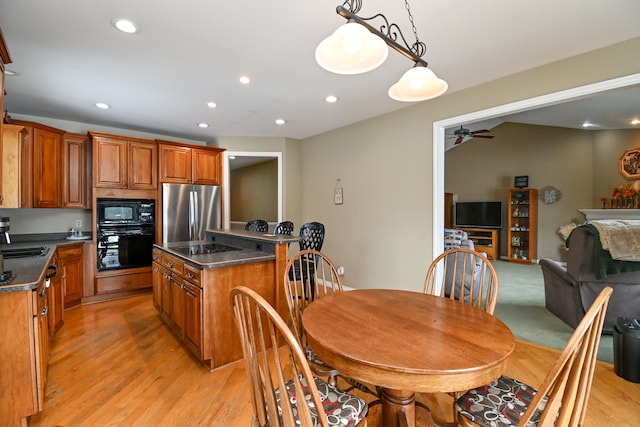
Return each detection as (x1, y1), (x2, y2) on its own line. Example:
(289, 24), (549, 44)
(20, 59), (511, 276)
(316, 22), (389, 74)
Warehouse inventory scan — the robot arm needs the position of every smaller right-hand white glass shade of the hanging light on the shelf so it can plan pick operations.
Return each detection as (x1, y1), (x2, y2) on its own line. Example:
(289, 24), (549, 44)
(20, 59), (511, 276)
(389, 66), (449, 102)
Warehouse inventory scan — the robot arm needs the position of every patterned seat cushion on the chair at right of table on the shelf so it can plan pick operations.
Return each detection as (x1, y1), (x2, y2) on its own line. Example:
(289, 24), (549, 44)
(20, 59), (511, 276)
(456, 375), (547, 427)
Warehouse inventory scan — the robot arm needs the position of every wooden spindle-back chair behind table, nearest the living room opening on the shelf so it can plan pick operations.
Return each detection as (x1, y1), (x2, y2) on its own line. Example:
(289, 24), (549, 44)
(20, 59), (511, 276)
(424, 248), (498, 314)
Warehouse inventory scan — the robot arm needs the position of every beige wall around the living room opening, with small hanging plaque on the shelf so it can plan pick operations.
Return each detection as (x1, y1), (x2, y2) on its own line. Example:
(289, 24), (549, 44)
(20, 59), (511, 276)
(301, 38), (640, 290)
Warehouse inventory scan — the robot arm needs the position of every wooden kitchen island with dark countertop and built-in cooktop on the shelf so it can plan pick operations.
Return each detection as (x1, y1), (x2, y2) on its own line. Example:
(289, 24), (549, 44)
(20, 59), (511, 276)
(152, 230), (298, 370)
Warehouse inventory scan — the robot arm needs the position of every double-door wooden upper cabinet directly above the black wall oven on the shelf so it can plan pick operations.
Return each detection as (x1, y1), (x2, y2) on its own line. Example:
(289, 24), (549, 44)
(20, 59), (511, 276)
(90, 132), (158, 190)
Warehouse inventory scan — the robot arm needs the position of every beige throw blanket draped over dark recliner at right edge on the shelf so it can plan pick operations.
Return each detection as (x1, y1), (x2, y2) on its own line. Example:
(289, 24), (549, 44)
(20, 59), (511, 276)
(590, 219), (640, 261)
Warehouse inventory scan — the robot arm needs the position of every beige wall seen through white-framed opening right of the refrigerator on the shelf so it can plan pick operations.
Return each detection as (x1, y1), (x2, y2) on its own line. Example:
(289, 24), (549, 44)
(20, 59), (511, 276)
(229, 159), (278, 222)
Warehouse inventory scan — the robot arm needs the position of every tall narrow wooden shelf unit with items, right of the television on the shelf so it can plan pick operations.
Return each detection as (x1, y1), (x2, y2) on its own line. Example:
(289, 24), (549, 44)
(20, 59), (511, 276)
(507, 188), (538, 264)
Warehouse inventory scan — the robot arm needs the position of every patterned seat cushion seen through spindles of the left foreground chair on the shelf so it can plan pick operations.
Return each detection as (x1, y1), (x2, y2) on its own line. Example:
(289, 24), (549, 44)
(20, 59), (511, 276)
(276, 377), (368, 427)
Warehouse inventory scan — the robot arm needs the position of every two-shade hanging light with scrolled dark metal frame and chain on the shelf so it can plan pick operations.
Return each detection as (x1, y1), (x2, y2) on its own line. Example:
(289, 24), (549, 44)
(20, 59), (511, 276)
(316, 0), (448, 102)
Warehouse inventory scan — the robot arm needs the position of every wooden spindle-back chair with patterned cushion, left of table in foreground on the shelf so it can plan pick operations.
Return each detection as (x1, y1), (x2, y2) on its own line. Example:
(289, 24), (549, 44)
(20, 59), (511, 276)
(231, 287), (368, 427)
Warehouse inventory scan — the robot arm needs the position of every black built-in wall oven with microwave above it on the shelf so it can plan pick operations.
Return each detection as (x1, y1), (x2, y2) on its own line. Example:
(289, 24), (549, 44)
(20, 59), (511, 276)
(96, 198), (155, 271)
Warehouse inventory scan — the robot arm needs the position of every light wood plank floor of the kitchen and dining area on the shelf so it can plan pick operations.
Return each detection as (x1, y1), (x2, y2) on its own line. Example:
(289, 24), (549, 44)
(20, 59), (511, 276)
(32, 295), (640, 427)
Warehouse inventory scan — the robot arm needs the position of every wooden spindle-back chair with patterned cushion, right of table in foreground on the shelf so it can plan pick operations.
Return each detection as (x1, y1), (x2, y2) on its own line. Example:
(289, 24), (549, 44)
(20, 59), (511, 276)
(456, 287), (613, 427)
